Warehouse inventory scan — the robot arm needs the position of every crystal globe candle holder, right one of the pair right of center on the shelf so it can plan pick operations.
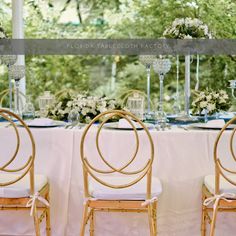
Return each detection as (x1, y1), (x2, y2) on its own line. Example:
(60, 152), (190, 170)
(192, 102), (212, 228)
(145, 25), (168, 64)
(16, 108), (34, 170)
(153, 58), (171, 125)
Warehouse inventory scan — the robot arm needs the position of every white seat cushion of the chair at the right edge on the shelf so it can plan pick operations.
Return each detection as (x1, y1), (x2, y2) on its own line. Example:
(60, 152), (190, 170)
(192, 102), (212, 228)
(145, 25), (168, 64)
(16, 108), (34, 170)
(204, 175), (236, 194)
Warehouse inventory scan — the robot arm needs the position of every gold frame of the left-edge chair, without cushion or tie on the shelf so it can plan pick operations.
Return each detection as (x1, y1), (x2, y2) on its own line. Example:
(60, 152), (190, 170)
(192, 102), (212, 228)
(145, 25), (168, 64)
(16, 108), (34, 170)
(0, 109), (51, 236)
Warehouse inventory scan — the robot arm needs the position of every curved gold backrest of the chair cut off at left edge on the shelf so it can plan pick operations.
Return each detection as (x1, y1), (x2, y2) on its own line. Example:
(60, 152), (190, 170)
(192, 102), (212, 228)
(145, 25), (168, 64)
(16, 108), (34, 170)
(0, 108), (35, 194)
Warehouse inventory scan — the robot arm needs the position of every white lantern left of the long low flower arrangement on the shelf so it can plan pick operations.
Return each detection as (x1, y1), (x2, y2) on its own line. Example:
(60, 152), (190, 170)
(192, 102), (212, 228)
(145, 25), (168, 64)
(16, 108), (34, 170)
(38, 91), (55, 117)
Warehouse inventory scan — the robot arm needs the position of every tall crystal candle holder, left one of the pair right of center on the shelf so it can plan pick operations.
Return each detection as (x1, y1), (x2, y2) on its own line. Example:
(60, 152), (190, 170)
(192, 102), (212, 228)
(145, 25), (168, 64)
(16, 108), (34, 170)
(139, 55), (156, 115)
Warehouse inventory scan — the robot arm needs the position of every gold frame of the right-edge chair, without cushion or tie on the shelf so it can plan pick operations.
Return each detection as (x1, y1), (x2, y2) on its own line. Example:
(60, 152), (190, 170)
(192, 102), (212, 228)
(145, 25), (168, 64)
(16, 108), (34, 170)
(201, 117), (236, 236)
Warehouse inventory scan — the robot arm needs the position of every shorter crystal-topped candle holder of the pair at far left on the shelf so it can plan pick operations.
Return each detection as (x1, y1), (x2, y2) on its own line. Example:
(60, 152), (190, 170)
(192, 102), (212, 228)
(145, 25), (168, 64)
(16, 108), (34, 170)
(9, 65), (25, 116)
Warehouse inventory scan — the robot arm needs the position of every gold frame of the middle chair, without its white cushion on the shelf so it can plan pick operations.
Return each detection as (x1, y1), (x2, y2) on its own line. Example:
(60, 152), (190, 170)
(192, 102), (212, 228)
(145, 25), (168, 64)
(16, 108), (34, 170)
(80, 110), (157, 236)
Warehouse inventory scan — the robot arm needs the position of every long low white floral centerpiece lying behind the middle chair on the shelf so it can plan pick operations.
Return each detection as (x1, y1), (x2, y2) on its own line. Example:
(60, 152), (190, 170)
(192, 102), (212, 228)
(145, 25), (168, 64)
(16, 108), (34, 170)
(47, 93), (121, 123)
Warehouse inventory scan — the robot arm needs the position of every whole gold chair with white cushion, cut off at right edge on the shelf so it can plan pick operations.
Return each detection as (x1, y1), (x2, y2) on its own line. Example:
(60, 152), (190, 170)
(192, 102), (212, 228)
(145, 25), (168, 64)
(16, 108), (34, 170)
(201, 117), (236, 236)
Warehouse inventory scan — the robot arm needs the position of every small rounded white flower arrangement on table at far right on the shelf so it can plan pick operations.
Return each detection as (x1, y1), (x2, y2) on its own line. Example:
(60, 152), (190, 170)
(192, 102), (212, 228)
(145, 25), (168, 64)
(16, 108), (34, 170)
(192, 90), (231, 115)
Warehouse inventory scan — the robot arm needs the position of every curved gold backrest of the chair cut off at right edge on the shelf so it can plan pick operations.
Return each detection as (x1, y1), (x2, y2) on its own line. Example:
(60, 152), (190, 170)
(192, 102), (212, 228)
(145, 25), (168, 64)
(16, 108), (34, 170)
(214, 117), (236, 194)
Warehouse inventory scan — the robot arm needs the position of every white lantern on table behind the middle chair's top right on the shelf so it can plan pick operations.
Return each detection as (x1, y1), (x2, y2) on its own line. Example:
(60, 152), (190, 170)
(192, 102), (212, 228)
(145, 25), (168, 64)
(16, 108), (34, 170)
(127, 93), (144, 120)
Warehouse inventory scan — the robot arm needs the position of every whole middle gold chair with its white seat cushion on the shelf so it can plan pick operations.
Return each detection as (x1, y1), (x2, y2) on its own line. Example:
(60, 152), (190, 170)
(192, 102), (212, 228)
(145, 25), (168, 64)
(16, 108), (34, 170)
(80, 110), (162, 236)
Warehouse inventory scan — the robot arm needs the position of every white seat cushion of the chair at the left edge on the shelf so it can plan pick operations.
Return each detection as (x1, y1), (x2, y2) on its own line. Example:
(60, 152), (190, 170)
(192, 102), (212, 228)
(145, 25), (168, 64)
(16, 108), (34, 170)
(0, 174), (48, 198)
